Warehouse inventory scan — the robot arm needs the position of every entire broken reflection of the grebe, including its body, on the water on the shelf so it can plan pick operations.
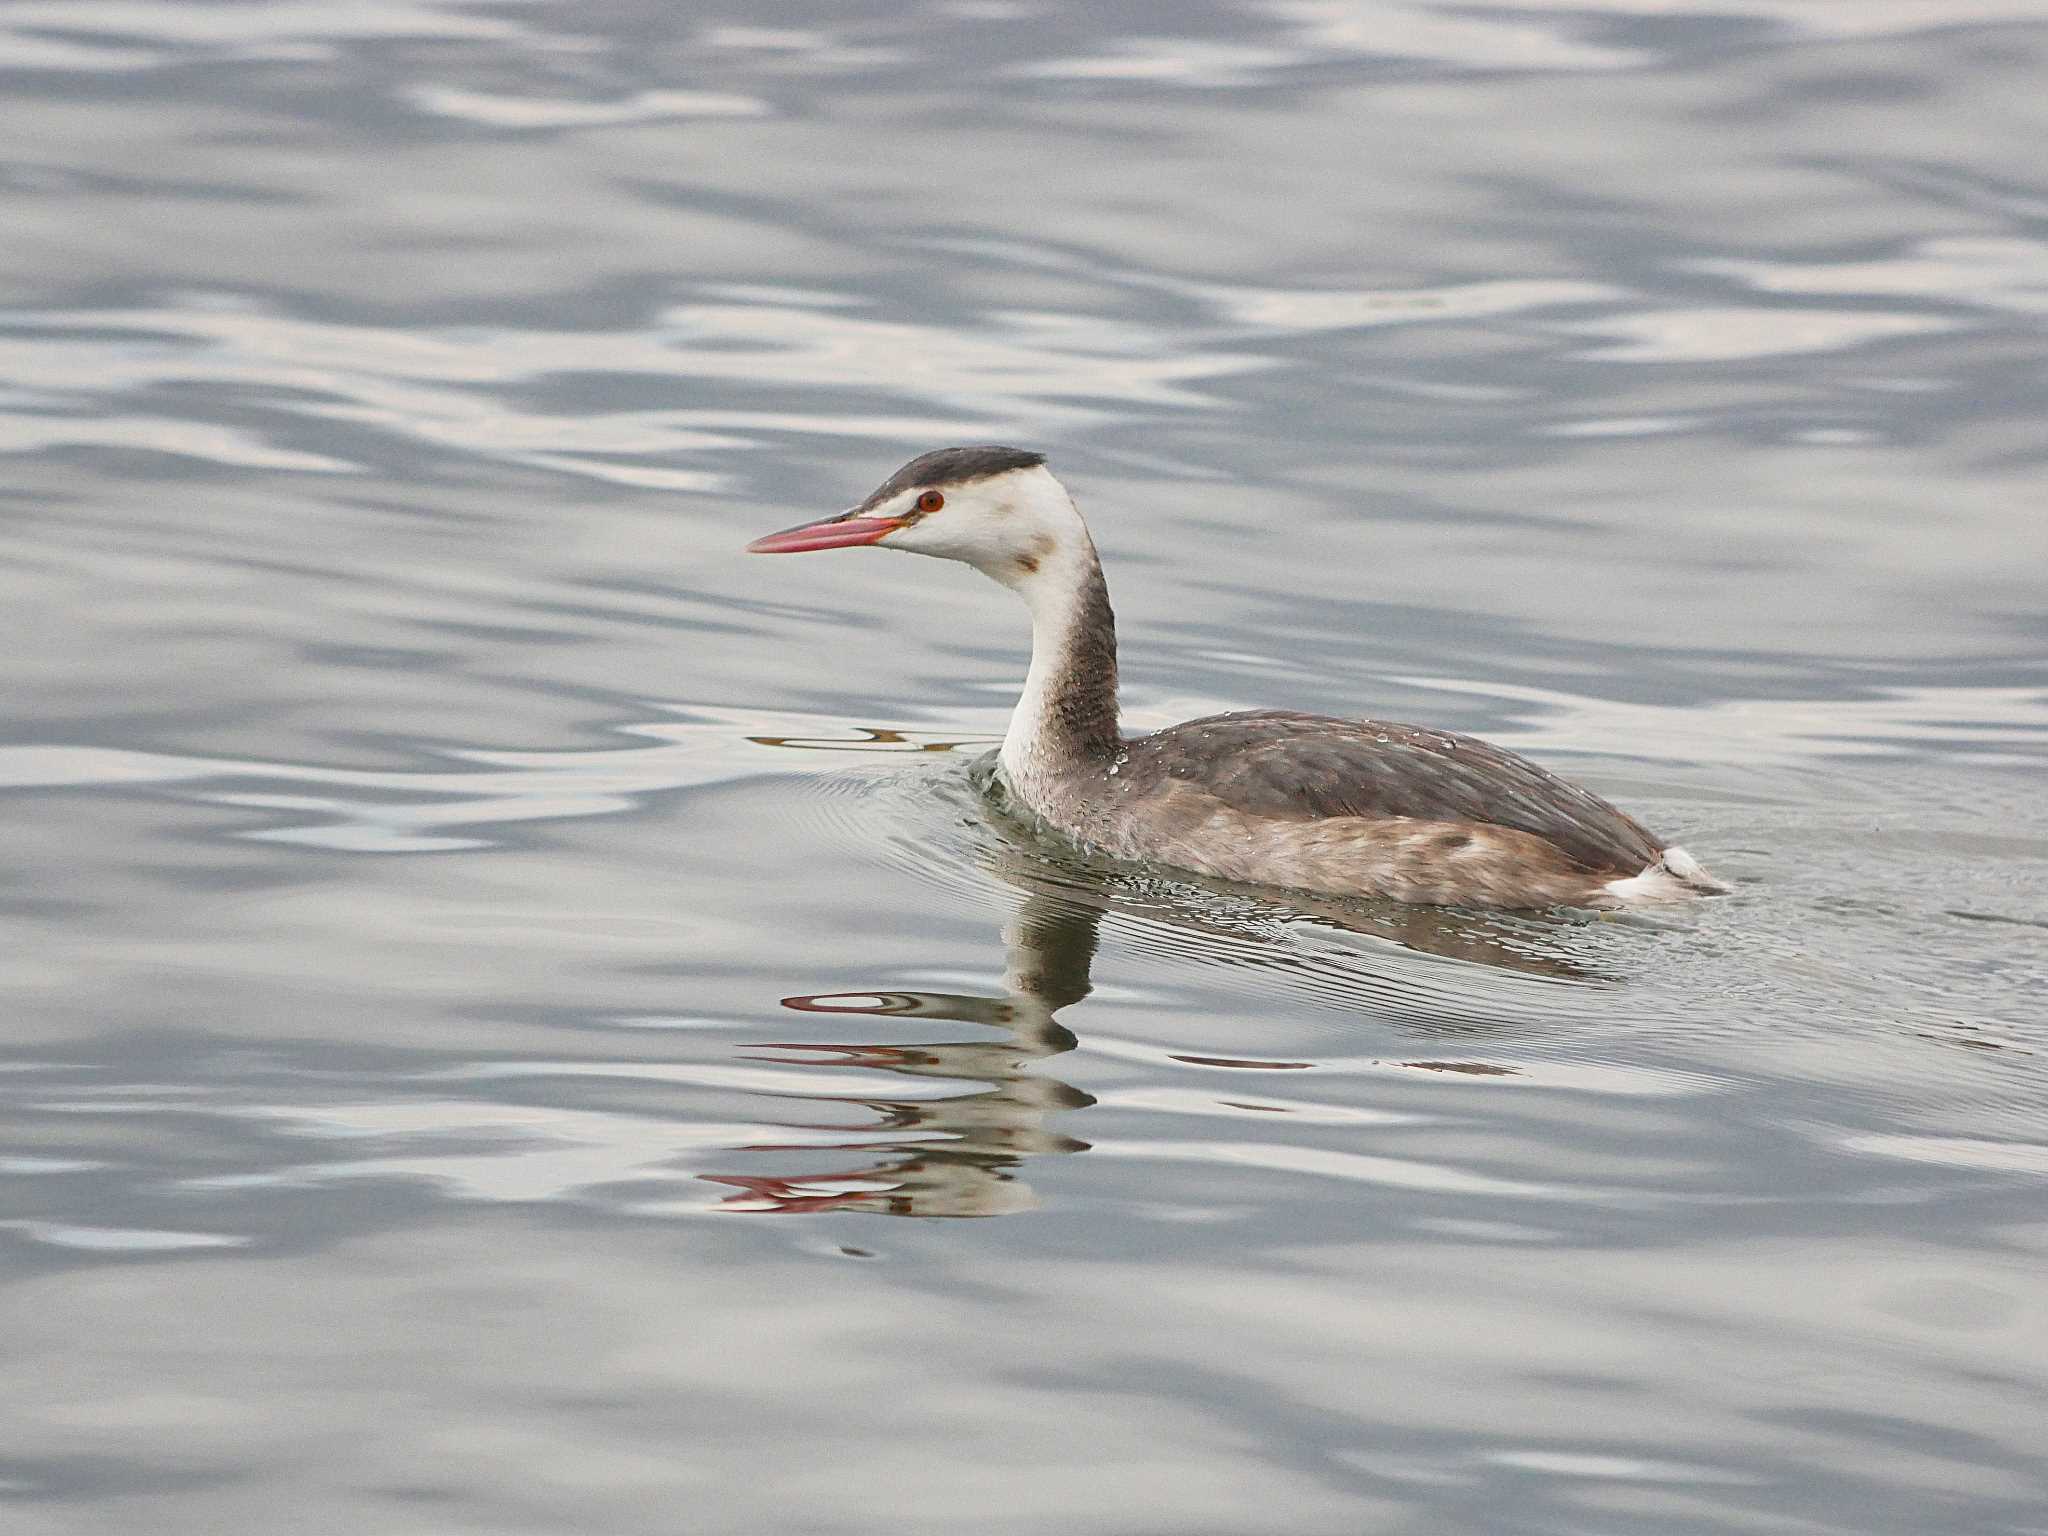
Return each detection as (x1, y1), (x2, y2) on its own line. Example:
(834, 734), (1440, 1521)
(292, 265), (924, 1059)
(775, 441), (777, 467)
(705, 729), (1610, 1217)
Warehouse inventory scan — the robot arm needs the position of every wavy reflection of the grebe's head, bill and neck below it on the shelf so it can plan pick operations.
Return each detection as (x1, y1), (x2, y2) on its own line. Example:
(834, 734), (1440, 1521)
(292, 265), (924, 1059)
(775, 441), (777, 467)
(709, 893), (1102, 1217)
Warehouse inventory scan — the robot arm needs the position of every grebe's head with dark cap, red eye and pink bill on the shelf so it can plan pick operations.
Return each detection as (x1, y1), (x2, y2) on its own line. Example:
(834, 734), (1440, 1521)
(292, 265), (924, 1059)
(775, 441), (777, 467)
(748, 446), (1092, 588)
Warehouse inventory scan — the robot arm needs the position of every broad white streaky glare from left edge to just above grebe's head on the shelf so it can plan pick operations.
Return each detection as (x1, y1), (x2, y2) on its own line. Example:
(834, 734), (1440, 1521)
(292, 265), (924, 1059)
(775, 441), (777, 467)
(0, 293), (1266, 479)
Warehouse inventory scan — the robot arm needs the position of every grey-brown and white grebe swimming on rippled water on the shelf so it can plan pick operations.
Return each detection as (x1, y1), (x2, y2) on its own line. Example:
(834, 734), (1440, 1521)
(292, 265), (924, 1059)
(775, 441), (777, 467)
(748, 446), (1726, 921)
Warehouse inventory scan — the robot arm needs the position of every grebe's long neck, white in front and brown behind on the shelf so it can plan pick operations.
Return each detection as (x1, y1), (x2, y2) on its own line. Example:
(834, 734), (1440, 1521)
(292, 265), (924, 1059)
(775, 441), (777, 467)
(1001, 535), (1118, 809)
